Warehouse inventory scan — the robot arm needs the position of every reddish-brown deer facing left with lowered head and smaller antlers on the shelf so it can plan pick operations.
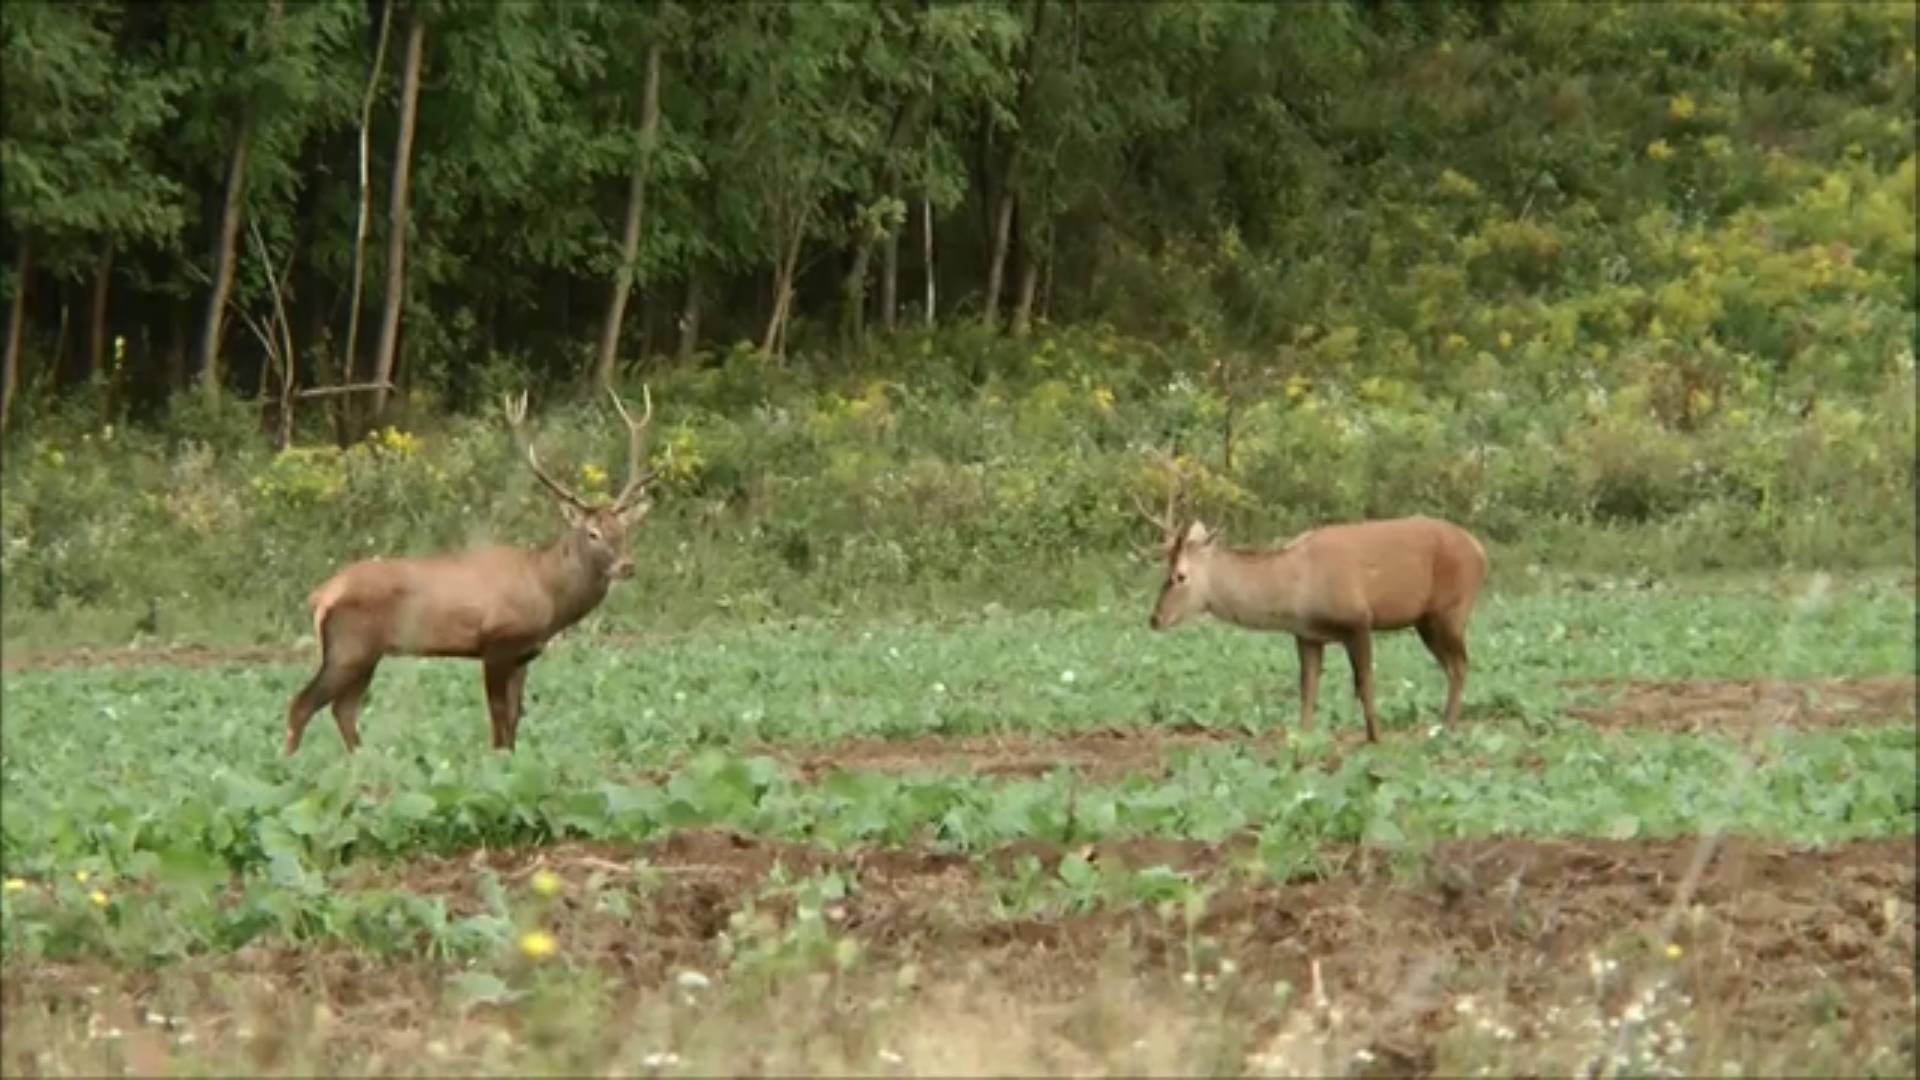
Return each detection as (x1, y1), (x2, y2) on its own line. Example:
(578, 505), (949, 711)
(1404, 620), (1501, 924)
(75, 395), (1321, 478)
(1133, 463), (1486, 742)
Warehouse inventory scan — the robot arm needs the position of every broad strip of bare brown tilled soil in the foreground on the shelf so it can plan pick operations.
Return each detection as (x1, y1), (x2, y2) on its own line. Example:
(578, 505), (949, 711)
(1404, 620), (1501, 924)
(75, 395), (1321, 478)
(0, 830), (1916, 1072)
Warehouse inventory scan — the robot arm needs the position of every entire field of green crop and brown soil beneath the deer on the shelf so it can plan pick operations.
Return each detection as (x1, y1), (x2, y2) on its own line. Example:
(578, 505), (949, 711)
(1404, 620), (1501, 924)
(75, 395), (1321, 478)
(0, 571), (1916, 1074)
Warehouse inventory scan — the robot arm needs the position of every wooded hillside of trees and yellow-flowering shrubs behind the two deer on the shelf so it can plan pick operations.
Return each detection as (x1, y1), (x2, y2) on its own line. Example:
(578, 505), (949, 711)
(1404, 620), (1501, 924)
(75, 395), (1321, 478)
(0, 0), (1916, 650)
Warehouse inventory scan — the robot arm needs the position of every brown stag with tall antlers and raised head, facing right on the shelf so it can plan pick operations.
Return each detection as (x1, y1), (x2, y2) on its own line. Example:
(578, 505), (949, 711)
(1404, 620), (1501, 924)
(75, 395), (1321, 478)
(286, 386), (655, 755)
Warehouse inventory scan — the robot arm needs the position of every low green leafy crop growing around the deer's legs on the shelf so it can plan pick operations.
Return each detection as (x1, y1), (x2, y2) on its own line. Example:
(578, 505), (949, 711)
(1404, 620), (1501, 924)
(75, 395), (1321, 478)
(0, 582), (1916, 960)
